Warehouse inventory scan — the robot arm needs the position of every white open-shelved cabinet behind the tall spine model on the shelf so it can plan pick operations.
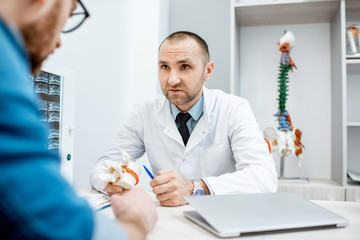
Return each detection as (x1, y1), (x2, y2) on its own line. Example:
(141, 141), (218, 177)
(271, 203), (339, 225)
(231, 0), (360, 201)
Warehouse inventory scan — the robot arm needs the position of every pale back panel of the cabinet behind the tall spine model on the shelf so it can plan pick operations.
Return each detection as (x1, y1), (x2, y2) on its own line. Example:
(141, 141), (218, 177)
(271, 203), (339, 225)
(240, 23), (331, 178)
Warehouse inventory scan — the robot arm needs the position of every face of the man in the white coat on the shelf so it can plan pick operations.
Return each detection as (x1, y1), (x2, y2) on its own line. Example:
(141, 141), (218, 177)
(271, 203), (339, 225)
(159, 38), (212, 112)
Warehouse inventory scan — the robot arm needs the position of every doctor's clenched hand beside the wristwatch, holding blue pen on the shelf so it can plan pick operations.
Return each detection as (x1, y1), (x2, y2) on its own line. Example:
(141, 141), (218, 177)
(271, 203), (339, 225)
(150, 169), (194, 207)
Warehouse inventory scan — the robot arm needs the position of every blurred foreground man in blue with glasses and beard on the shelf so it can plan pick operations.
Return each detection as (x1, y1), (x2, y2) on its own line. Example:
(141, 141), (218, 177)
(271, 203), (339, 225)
(0, 0), (157, 239)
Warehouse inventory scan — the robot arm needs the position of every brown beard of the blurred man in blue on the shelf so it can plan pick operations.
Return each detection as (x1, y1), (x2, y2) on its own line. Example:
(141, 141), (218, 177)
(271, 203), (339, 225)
(20, 0), (61, 76)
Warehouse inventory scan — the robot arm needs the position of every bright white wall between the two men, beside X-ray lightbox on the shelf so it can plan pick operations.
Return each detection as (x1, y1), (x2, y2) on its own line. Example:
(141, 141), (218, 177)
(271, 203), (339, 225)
(48, 0), (168, 187)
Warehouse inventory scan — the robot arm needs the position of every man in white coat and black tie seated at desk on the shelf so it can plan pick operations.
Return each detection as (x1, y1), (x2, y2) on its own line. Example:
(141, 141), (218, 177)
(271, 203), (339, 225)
(91, 32), (277, 206)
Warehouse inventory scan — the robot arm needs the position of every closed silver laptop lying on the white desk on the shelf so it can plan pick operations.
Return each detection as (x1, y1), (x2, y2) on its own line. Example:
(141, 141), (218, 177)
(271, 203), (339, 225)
(184, 192), (348, 237)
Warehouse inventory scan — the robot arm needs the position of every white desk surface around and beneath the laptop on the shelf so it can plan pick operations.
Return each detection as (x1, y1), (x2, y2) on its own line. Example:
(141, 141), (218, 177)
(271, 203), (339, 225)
(101, 194), (360, 240)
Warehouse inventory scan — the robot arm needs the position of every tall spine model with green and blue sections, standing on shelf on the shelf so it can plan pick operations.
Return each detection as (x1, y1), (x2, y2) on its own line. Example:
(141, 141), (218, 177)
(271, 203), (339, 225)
(264, 31), (304, 166)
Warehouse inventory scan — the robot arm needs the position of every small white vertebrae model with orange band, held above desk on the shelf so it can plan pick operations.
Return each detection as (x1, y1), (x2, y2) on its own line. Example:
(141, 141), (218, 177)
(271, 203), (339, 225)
(99, 152), (141, 189)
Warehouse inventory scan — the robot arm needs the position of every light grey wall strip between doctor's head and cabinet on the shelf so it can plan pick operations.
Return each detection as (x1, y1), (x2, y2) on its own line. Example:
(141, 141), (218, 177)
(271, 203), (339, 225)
(169, 0), (230, 93)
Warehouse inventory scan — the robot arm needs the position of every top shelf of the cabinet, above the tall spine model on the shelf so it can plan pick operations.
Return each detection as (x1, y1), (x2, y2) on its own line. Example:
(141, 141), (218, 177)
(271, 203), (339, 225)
(235, 0), (339, 26)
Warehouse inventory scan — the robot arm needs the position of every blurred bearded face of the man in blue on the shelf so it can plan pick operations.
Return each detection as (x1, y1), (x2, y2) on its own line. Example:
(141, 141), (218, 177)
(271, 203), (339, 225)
(20, 0), (77, 75)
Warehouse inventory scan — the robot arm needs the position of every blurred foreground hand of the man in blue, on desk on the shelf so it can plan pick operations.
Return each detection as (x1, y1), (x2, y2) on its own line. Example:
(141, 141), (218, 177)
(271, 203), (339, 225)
(111, 188), (158, 240)
